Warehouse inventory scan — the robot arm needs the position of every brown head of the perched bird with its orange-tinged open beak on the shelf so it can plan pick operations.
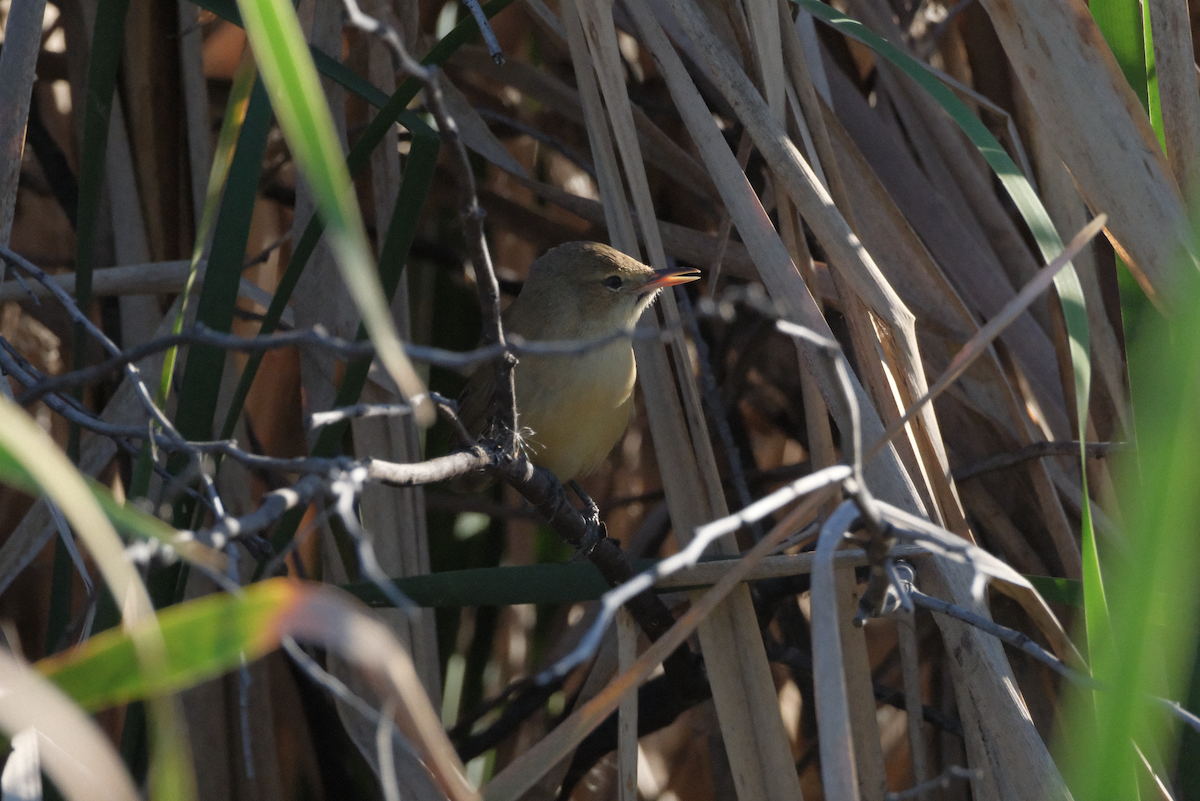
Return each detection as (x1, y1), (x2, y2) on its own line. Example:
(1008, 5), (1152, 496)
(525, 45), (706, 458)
(521, 242), (700, 337)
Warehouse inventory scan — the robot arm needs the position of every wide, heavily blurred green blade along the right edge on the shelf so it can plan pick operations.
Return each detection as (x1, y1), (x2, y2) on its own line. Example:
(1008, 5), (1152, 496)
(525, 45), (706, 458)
(1060, 265), (1200, 801)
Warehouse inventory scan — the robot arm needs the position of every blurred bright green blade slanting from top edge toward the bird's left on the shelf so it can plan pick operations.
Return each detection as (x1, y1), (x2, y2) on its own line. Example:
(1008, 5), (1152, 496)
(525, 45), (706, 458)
(238, 0), (434, 426)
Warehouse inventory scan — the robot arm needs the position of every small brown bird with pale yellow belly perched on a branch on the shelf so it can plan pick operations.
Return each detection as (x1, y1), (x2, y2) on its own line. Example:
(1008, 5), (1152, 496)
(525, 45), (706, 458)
(458, 242), (700, 483)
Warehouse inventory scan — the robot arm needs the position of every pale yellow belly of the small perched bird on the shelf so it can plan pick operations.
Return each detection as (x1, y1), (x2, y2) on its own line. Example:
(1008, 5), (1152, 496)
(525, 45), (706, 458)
(516, 343), (636, 482)
